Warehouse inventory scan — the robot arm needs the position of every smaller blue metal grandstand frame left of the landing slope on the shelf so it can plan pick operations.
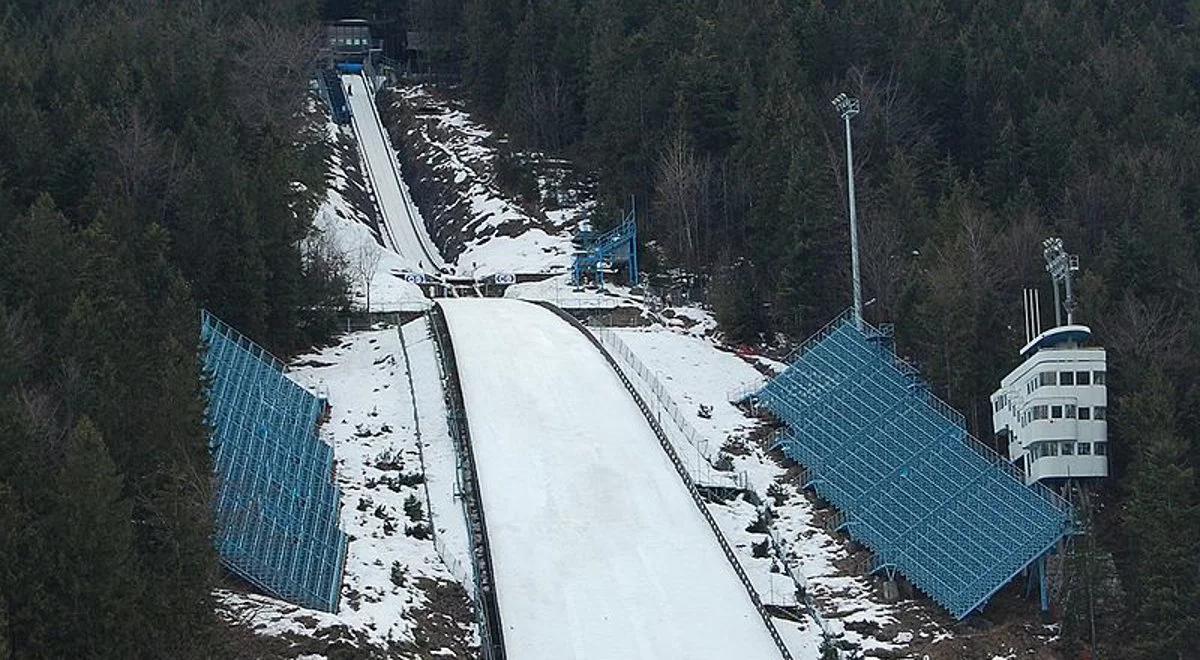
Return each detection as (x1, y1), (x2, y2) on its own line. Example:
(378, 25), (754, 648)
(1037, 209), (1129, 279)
(200, 312), (347, 612)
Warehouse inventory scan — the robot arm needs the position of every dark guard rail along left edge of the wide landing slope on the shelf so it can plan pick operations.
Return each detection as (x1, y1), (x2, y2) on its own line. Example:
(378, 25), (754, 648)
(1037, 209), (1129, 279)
(428, 304), (506, 660)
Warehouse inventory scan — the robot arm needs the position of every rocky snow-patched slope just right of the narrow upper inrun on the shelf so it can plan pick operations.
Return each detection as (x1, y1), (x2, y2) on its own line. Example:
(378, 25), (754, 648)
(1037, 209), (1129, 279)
(382, 85), (592, 277)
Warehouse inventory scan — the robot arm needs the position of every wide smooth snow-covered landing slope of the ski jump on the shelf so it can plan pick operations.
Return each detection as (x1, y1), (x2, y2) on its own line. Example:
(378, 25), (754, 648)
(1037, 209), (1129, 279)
(442, 299), (779, 660)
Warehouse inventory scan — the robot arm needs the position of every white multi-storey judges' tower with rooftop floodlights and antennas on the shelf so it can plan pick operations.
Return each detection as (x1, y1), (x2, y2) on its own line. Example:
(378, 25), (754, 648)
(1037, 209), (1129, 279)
(991, 239), (1109, 484)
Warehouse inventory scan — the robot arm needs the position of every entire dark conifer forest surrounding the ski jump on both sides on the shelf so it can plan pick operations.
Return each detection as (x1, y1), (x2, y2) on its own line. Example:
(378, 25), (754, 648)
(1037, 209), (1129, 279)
(0, 0), (1200, 660)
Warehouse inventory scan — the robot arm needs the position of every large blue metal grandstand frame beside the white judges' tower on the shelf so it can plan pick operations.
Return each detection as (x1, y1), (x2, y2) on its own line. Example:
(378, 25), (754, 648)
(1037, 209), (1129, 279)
(754, 312), (1073, 619)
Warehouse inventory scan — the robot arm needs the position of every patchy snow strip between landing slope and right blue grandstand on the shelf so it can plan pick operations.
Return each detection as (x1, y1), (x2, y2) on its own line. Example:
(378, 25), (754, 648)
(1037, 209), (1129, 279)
(604, 324), (944, 658)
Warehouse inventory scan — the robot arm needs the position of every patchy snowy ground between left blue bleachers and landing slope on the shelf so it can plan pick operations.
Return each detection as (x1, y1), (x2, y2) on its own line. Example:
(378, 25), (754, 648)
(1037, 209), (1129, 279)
(218, 328), (475, 659)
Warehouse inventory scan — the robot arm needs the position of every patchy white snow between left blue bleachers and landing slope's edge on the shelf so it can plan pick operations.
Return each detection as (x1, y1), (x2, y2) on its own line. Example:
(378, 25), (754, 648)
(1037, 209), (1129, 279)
(217, 322), (473, 648)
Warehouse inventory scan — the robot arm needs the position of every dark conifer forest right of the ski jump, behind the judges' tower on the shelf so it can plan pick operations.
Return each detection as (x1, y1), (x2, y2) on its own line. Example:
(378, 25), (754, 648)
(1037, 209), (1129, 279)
(393, 0), (1200, 658)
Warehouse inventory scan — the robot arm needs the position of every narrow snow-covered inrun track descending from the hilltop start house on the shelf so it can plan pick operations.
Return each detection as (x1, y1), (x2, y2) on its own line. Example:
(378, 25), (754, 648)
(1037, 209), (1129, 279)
(342, 76), (445, 274)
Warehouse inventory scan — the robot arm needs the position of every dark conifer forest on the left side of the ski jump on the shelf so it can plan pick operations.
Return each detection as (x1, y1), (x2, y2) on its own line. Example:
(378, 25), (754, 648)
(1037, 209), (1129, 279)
(0, 0), (344, 659)
